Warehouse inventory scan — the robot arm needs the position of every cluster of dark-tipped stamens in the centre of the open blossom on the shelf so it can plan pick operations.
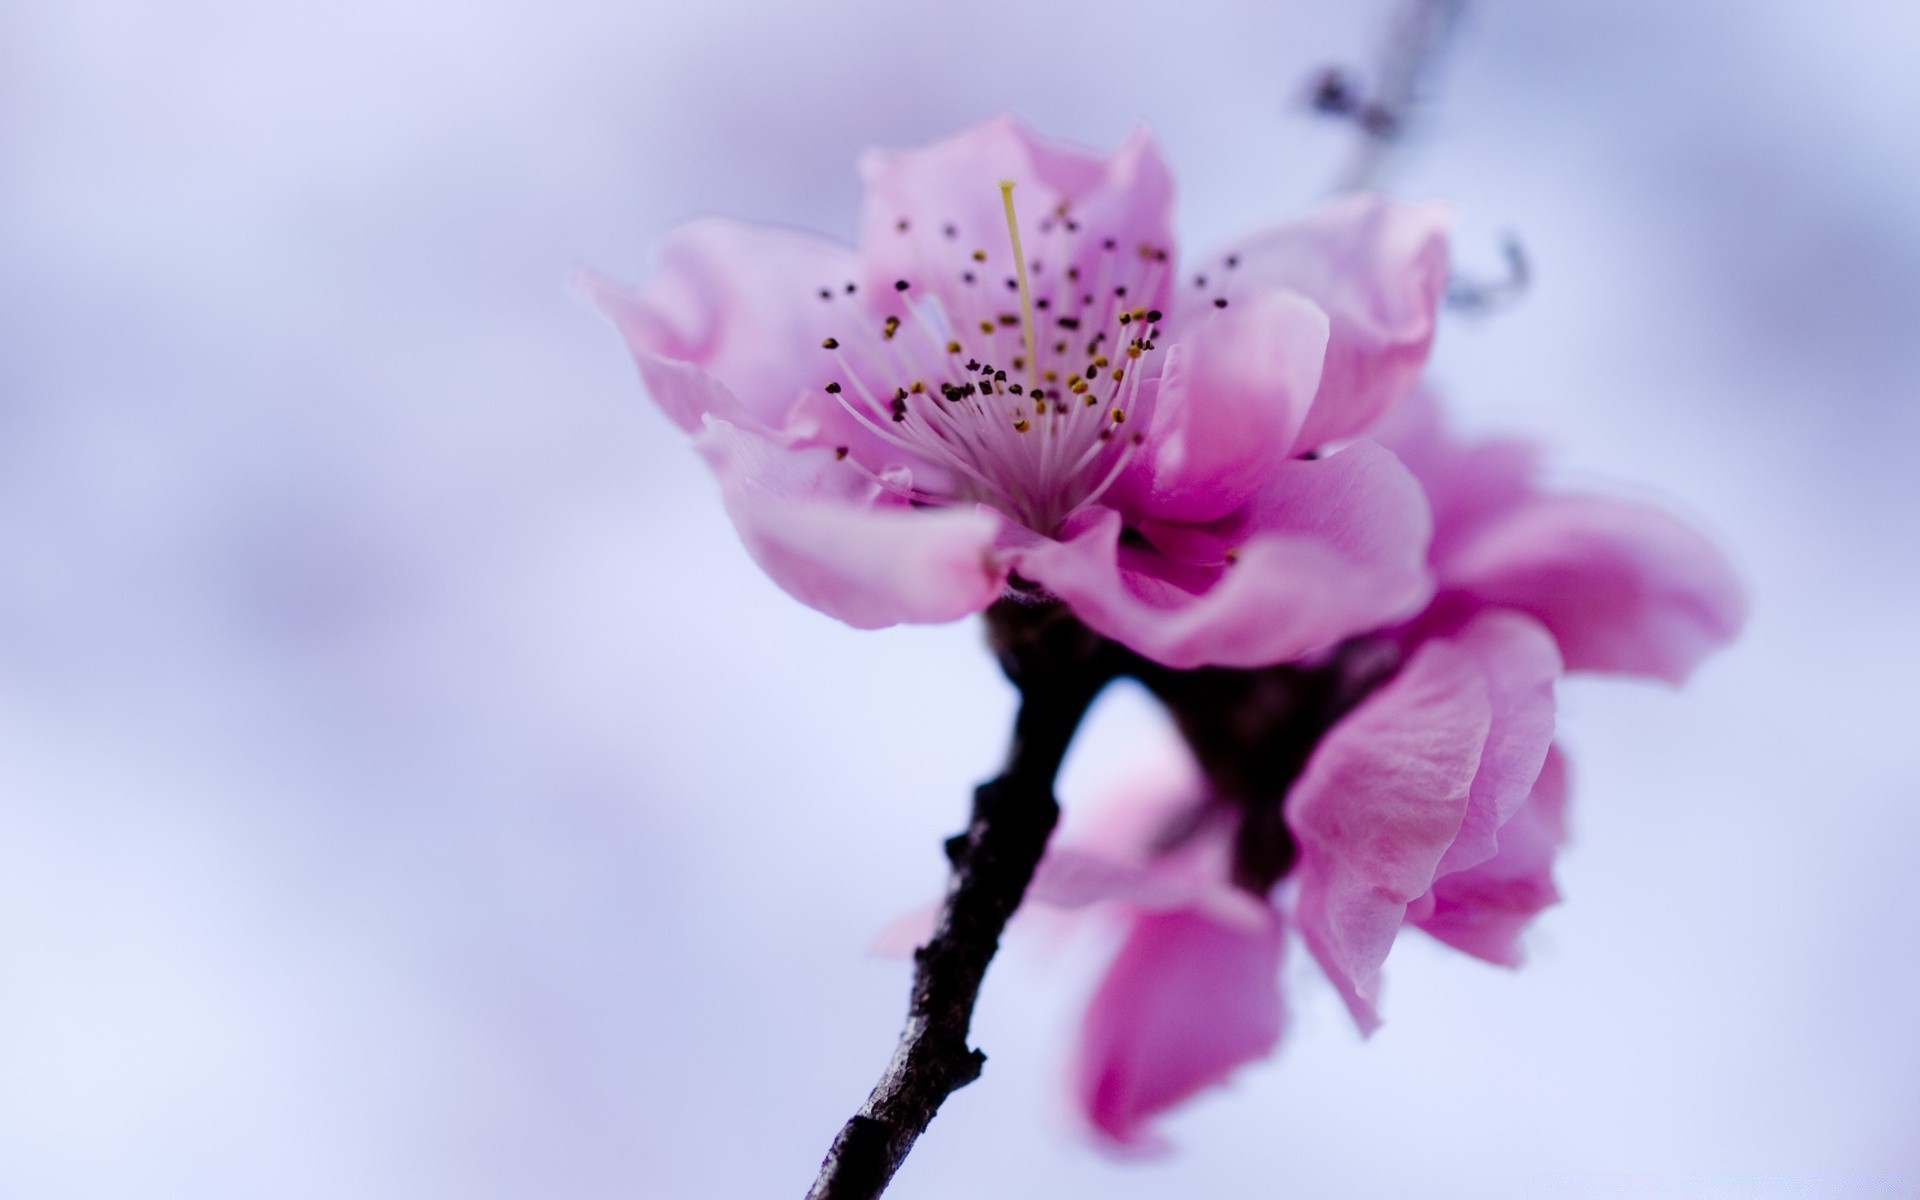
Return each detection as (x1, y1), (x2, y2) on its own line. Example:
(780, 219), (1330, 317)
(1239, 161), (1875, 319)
(822, 182), (1167, 536)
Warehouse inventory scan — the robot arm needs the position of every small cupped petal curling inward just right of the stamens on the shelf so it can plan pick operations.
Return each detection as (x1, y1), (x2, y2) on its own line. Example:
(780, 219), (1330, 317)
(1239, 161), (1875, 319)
(1137, 290), (1327, 520)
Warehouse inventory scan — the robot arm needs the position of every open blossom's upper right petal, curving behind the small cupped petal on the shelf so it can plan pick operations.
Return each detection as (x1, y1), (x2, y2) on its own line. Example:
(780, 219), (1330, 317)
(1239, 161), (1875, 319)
(1202, 196), (1450, 453)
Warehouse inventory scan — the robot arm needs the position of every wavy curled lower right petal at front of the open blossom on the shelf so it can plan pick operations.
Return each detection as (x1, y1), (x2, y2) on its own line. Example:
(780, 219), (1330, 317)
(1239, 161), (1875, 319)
(1006, 442), (1430, 668)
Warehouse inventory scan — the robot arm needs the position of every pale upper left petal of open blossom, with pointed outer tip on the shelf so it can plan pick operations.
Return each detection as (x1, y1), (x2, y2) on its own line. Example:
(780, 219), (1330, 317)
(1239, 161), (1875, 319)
(580, 219), (854, 432)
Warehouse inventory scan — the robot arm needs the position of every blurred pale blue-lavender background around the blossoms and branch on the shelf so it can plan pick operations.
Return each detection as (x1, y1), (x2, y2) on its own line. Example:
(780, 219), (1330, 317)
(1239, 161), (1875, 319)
(0, 0), (1920, 1200)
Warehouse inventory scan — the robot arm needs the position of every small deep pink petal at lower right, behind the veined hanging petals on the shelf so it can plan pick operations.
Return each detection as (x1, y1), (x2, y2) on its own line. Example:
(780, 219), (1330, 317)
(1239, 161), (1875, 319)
(1417, 749), (1567, 966)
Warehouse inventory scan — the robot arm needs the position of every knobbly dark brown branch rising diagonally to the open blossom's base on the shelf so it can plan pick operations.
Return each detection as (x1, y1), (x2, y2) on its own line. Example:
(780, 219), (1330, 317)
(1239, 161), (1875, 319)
(806, 601), (1123, 1200)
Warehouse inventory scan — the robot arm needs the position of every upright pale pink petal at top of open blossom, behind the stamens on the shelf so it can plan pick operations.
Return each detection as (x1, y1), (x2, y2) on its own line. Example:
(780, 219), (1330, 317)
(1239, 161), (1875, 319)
(860, 117), (1173, 311)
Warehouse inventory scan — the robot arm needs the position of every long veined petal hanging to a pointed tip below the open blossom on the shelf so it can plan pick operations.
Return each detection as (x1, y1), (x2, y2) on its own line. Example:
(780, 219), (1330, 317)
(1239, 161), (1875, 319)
(1286, 641), (1494, 1033)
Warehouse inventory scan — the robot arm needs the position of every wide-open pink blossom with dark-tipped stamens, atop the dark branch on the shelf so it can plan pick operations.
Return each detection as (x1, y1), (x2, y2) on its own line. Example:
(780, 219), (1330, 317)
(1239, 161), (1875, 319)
(586, 117), (1446, 666)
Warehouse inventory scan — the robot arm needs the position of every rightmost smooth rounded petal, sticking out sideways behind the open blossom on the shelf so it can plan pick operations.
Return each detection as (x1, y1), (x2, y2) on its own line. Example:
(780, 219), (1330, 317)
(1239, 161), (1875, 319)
(1436, 495), (1747, 684)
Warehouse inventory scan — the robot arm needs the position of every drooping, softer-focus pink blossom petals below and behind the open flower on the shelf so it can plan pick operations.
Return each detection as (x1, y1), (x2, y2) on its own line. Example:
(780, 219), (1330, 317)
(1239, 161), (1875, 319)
(1033, 397), (1745, 1144)
